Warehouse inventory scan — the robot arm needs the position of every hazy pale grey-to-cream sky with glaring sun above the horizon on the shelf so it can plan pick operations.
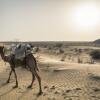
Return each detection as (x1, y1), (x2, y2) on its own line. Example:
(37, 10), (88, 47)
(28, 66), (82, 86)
(0, 0), (100, 41)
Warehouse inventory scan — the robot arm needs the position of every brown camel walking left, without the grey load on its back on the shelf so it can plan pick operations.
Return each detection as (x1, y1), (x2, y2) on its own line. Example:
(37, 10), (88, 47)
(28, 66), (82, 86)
(0, 46), (42, 95)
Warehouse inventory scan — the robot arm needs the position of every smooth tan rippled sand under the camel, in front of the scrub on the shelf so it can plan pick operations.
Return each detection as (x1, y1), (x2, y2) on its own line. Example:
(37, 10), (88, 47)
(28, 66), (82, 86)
(0, 54), (100, 100)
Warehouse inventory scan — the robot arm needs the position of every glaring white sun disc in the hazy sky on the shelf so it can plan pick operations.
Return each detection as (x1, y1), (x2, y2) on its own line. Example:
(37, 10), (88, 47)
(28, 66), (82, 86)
(73, 5), (99, 29)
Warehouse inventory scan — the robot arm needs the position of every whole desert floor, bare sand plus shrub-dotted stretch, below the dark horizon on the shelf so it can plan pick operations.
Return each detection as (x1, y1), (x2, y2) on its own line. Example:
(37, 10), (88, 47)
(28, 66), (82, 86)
(0, 42), (100, 100)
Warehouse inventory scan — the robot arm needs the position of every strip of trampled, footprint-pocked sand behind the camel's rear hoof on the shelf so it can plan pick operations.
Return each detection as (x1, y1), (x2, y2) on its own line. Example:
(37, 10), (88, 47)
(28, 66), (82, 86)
(43, 85), (100, 100)
